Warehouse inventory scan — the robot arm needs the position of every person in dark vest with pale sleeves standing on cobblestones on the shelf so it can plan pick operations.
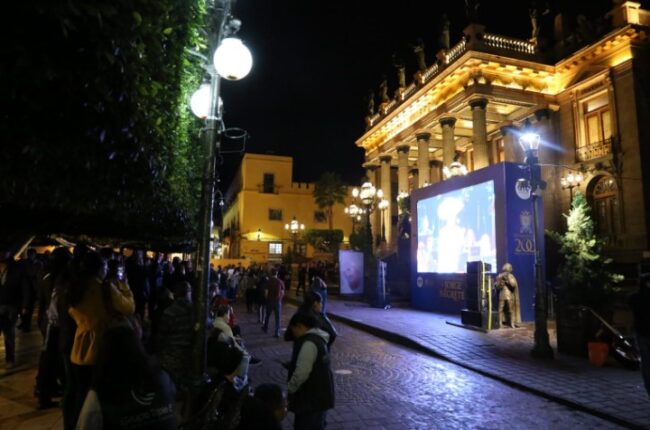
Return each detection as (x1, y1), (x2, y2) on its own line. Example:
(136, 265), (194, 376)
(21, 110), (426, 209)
(287, 312), (334, 430)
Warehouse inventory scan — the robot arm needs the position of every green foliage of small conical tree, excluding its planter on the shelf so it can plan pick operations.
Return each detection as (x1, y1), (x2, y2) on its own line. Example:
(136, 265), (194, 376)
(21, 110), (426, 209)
(547, 193), (623, 311)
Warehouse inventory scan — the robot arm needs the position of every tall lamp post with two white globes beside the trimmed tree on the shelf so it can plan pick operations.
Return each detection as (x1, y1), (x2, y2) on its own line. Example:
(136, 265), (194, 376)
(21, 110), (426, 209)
(190, 0), (252, 385)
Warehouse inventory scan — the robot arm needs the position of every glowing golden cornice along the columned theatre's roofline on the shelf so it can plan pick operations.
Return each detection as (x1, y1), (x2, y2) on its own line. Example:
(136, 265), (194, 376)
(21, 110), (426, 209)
(356, 25), (647, 154)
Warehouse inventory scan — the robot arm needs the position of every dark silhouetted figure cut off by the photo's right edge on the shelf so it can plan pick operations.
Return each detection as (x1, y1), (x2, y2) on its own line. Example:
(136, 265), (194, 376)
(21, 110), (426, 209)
(628, 273), (650, 396)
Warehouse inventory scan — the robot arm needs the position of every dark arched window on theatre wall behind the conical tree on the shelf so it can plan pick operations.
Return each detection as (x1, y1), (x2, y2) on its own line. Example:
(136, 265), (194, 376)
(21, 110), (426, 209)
(591, 176), (618, 245)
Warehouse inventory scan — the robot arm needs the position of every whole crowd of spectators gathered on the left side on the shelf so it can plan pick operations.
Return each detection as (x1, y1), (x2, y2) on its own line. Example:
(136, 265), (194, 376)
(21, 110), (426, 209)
(0, 244), (337, 430)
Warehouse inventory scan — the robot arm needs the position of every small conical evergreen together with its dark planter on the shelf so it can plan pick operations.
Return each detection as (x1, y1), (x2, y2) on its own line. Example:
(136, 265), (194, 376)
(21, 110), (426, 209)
(547, 193), (623, 356)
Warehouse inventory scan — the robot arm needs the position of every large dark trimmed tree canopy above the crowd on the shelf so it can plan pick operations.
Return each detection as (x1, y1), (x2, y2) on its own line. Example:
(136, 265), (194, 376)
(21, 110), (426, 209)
(0, 0), (208, 244)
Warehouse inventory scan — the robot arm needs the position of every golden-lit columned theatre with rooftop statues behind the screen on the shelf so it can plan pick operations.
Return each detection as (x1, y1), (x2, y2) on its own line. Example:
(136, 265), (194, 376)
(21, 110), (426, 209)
(356, 1), (650, 263)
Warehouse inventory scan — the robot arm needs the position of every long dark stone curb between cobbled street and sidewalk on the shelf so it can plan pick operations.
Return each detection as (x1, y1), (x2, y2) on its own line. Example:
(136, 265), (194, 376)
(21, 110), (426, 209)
(285, 296), (645, 430)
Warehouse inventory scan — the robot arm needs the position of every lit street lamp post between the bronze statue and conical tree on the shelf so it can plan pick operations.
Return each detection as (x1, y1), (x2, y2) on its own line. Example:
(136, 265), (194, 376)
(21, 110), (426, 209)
(519, 132), (553, 358)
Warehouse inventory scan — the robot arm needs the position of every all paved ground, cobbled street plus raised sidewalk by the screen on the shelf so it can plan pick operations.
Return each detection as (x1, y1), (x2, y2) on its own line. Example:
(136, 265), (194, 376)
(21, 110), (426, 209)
(0, 293), (650, 430)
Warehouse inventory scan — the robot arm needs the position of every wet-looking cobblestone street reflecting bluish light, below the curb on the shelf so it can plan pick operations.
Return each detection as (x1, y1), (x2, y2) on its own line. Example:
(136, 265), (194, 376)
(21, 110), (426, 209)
(237, 306), (620, 430)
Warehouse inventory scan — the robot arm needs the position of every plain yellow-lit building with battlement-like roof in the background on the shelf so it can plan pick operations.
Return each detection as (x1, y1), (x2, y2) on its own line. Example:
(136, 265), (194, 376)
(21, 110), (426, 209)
(222, 153), (352, 263)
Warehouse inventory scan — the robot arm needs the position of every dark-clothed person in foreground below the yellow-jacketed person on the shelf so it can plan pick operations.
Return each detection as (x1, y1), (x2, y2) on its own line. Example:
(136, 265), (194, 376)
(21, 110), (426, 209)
(77, 326), (177, 430)
